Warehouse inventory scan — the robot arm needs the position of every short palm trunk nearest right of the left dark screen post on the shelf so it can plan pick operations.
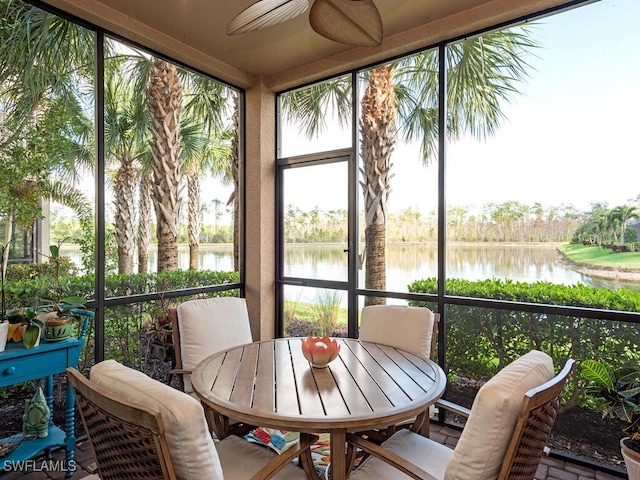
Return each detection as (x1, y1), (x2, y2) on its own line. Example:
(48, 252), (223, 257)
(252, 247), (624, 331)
(114, 157), (136, 274)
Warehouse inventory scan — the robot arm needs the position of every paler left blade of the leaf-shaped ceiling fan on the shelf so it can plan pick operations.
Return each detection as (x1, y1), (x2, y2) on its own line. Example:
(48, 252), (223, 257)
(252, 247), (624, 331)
(227, 0), (309, 35)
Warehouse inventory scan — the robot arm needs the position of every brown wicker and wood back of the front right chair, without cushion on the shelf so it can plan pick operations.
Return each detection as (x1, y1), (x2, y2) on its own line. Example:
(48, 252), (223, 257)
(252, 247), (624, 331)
(498, 359), (575, 480)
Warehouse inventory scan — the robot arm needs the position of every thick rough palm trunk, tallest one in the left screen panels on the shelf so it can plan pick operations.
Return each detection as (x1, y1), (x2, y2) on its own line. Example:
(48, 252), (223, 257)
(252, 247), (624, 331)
(147, 58), (182, 273)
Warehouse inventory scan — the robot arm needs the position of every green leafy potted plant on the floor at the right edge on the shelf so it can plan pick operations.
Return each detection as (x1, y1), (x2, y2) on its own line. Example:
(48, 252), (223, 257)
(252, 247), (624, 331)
(581, 360), (640, 480)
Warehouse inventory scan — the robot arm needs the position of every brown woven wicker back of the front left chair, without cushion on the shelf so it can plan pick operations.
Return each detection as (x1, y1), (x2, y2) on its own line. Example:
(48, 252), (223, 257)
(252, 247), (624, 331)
(67, 368), (176, 480)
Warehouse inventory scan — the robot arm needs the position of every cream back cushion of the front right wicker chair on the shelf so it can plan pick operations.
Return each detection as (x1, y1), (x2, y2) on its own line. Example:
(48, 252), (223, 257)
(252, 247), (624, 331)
(444, 350), (553, 480)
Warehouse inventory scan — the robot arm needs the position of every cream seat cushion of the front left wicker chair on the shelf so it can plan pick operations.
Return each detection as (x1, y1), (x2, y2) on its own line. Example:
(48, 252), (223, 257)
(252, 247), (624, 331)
(215, 435), (307, 480)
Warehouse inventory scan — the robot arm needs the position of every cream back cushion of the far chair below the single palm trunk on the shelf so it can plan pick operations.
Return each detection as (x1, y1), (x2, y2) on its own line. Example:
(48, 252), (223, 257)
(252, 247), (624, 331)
(358, 305), (435, 358)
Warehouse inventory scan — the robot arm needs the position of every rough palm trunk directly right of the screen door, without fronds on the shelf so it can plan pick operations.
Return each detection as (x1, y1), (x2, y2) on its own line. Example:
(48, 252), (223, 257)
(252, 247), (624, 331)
(360, 66), (396, 305)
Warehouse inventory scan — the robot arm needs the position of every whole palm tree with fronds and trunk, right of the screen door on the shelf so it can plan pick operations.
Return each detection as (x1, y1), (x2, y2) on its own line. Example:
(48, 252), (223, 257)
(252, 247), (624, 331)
(282, 28), (537, 304)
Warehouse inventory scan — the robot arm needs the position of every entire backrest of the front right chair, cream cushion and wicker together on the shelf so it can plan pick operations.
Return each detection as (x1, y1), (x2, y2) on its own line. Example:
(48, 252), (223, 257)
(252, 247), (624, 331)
(445, 350), (573, 480)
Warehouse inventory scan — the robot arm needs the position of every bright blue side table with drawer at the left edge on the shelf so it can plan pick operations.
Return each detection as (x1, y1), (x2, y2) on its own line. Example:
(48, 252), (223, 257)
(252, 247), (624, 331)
(0, 310), (94, 477)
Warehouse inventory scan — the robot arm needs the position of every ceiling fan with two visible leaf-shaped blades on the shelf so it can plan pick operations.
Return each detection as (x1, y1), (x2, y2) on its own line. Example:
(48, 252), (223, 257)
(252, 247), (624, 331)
(227, 0), (382, 47)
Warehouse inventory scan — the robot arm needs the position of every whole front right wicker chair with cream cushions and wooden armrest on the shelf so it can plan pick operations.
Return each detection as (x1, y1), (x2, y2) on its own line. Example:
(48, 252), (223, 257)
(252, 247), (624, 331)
(347, 351), (574, 480)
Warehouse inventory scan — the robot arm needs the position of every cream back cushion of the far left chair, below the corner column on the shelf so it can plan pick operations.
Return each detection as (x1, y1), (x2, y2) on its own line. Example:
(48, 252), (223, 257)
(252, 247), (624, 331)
(177, 297), (253, 393)
